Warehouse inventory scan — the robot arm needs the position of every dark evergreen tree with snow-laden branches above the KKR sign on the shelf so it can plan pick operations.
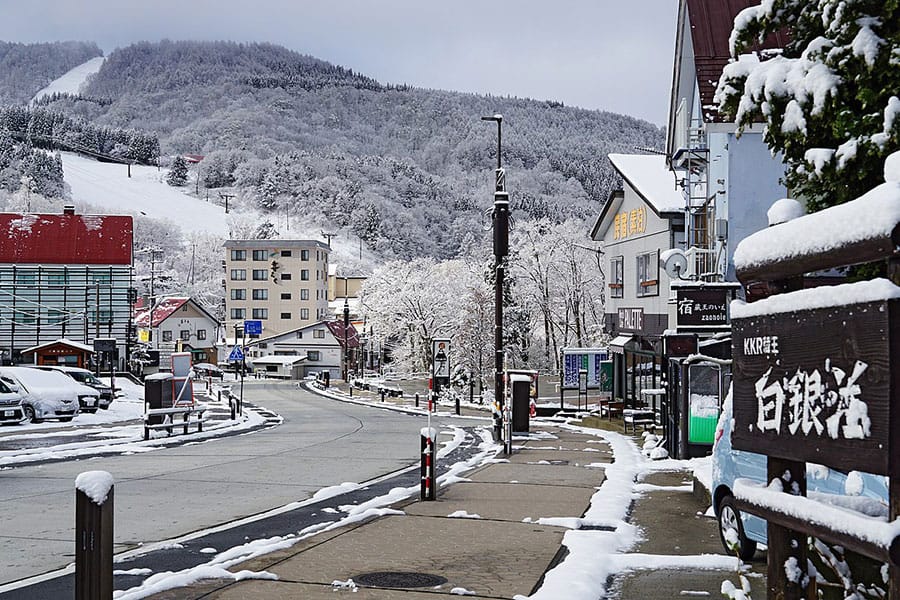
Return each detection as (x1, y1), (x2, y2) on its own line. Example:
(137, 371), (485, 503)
(716, 0), (900, 210)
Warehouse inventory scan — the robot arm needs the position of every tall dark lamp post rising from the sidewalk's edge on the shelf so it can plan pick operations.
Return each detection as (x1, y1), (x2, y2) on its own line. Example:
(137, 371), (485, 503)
(481, 115), (509, 451)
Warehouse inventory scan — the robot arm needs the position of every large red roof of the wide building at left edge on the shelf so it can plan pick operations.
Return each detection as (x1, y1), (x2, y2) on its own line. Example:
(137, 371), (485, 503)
(0, 213), (133, 265)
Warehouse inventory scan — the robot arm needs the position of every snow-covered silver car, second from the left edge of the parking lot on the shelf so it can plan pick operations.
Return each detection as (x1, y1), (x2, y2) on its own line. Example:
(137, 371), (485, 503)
(0, 367), (94, 423)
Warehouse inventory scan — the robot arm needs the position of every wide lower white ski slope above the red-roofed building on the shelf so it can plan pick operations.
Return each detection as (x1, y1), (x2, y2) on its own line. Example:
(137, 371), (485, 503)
(60, 152), (228, 237)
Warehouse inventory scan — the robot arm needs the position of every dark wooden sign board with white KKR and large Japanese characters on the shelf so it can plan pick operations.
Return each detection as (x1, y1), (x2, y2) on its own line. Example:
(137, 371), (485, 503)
(732, 300), (900, 477)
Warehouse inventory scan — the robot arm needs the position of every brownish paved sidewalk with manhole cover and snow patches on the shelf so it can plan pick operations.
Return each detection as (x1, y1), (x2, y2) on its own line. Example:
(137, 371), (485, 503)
(144, 428), (611, 600)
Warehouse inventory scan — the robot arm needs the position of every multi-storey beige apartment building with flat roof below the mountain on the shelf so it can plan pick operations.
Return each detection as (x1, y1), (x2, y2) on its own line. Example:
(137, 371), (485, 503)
(224, 240), (331, 338)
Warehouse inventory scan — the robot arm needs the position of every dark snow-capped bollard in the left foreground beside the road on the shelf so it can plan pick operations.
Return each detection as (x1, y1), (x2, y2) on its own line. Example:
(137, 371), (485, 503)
(75, 471), (114, 600)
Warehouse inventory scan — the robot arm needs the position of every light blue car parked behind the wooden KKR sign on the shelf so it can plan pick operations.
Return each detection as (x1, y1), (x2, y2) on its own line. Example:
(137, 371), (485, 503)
(712, 393), (888, 560)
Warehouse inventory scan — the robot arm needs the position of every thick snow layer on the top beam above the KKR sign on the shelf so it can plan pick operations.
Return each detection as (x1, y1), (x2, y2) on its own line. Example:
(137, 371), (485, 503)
(734, 182), (900, 270)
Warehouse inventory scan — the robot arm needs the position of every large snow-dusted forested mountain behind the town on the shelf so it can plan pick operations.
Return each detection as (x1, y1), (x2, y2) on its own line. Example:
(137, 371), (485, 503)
(24, 41), (663, 259)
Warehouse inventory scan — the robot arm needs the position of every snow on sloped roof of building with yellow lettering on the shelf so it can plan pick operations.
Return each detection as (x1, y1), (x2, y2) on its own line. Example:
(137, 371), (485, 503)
(609, 154), (684, 213)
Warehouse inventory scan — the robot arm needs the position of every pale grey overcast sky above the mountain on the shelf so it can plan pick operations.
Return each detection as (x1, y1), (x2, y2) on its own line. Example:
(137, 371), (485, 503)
(0, 0), (678, 125)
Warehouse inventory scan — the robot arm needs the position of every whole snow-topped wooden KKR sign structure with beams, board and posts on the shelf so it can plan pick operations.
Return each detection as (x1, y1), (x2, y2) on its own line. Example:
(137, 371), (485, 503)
(731, 163), (900, 600)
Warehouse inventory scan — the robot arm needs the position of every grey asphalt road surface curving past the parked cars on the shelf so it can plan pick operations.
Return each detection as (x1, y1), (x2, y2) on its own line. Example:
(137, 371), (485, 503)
(0, 383), (444, 586)
